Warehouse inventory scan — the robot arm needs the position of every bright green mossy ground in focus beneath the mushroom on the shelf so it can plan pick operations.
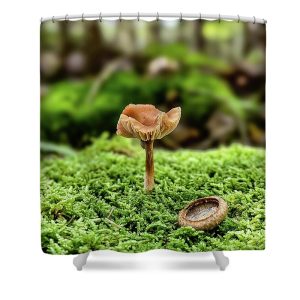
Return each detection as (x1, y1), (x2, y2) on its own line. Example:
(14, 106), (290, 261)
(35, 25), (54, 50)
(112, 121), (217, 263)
(41, 135), (265, 254)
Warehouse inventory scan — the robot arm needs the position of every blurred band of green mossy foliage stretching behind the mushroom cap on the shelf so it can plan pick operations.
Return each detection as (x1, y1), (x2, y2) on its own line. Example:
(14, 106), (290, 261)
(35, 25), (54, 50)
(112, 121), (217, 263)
(41, 71), (259, 147)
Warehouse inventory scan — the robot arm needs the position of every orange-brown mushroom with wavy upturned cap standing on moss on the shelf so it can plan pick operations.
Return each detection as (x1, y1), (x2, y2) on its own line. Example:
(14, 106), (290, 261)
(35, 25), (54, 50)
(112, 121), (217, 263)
(117, 104), (181, 191)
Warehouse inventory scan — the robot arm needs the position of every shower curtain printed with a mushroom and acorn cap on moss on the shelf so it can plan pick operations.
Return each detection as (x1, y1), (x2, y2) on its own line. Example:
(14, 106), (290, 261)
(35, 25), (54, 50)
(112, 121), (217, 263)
(40, 19), (266, 254)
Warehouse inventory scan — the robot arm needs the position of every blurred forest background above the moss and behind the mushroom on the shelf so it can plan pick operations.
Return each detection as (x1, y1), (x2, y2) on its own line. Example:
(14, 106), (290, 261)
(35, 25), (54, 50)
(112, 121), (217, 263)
(40, 20), (265, 152)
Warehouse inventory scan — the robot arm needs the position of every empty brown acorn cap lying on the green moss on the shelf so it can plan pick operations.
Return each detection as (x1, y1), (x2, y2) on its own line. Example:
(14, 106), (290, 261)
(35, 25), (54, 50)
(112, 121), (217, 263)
(178, 196), (228, 230)
